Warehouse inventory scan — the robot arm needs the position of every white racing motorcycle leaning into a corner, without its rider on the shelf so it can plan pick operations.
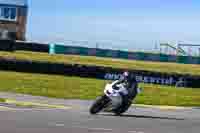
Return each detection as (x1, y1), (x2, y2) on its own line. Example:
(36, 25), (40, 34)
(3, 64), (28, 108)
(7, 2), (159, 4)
(90, 81), (141, 115)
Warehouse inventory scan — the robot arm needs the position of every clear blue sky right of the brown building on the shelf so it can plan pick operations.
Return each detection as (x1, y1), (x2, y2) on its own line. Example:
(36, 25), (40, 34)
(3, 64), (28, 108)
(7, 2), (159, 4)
(27, 0), (200, 50)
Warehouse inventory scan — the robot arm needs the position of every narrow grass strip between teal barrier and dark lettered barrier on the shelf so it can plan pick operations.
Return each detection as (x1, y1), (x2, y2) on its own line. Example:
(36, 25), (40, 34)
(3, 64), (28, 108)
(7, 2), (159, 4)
(0, 51), (200, 75)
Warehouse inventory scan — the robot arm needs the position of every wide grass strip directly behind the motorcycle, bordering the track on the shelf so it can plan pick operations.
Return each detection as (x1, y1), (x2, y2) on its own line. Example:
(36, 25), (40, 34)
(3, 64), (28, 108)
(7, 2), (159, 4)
(0, 71), (200, 106)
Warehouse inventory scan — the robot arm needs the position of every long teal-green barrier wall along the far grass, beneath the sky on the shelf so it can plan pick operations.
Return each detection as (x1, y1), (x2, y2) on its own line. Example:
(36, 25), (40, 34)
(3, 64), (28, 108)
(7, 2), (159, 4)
(51, 45), (200, 64)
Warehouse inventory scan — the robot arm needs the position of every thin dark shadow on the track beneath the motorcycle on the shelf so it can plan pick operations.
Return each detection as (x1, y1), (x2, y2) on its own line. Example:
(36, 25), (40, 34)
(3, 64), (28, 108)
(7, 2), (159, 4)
(98, 113), (185, 121)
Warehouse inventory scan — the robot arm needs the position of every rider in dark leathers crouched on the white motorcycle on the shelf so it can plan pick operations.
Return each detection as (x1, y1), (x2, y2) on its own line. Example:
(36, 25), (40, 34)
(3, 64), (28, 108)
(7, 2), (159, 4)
(113, 71), (138, 112)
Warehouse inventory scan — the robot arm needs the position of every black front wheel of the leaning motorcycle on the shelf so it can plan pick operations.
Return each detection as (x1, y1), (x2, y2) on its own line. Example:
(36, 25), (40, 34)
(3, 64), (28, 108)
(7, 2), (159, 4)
(90, 95), (110, 114)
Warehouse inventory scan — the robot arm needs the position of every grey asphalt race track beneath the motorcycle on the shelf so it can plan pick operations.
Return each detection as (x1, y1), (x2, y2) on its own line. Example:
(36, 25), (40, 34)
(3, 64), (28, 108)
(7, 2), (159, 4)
(0, 94), (200, 133)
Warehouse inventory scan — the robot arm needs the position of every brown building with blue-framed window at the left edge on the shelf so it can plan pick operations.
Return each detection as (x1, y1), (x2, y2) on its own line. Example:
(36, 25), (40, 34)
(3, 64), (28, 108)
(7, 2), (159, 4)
(0, 0), (28, 41)
